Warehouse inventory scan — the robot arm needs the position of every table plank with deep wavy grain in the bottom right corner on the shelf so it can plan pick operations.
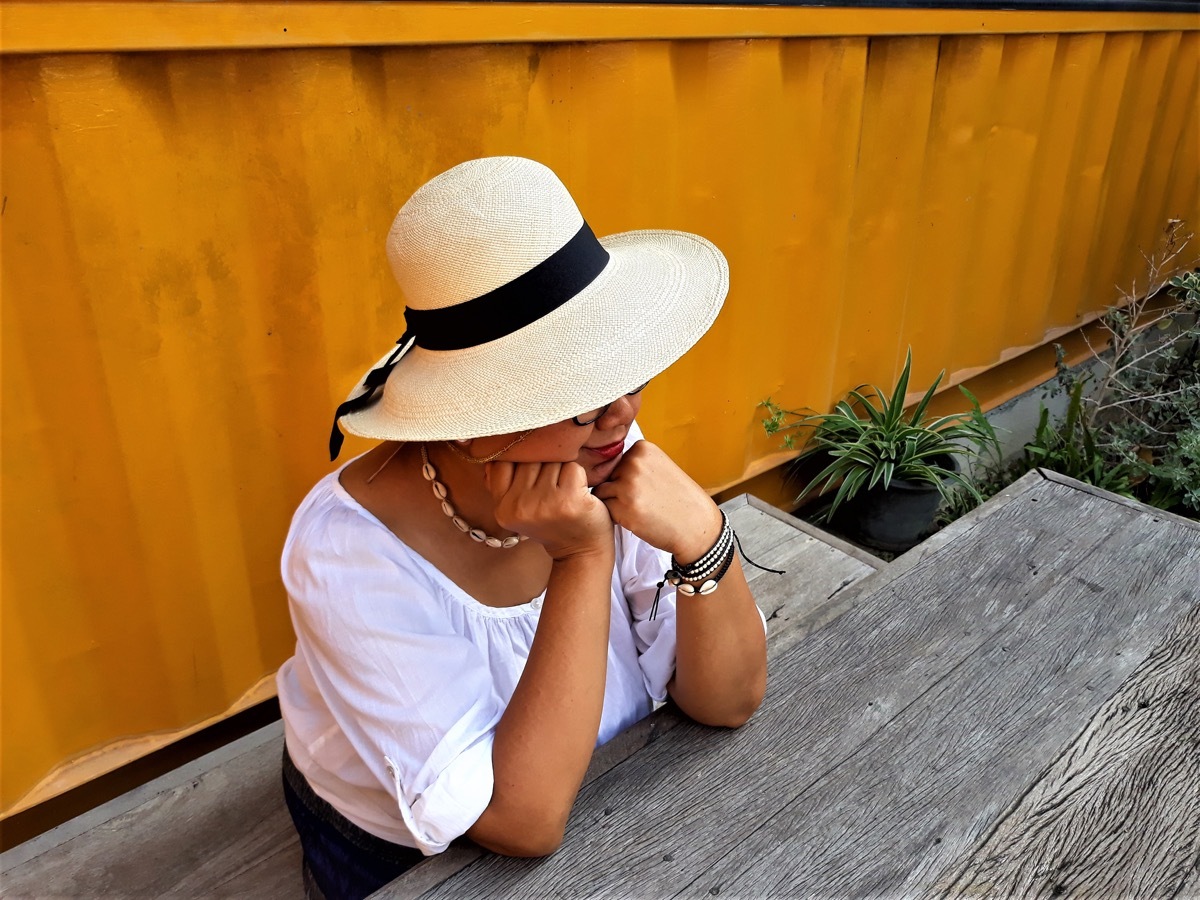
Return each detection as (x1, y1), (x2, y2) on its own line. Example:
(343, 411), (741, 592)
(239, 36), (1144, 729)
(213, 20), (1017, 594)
(930, 602), (1200, 898)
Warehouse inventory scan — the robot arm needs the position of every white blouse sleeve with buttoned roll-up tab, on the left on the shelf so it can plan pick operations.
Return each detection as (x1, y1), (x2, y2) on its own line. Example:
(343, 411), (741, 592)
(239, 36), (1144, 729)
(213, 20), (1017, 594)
(283, 510), (504, 854)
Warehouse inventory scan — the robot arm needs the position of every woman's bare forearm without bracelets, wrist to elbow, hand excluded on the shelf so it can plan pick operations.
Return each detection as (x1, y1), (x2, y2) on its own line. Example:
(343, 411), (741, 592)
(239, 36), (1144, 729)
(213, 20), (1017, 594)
(467, 540), (613, 856)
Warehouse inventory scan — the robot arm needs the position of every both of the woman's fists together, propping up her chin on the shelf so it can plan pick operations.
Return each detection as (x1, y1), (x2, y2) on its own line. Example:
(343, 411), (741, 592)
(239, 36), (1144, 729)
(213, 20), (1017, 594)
(485, 440), (721, 563)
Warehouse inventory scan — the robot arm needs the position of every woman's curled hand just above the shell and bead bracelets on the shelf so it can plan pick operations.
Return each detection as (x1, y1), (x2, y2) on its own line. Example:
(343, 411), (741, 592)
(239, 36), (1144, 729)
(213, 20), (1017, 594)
(593, 440), (721, 563)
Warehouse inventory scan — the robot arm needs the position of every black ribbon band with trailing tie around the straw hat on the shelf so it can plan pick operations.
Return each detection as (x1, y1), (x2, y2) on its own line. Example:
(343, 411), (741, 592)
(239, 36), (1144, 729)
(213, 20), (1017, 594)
(329, 222), (608, 461)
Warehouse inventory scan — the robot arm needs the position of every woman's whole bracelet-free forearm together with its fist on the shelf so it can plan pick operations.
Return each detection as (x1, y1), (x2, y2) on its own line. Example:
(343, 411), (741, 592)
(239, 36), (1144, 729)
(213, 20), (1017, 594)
(467, 462), (614, 856)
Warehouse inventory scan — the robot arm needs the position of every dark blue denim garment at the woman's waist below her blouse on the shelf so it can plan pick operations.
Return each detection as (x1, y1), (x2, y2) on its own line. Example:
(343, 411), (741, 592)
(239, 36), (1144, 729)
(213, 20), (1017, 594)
(283, 748), (425, 900)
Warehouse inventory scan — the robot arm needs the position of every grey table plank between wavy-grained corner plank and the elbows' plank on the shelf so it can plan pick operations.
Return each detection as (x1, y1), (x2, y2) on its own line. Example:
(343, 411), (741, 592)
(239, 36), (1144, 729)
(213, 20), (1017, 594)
(679, 504), (1200, 898)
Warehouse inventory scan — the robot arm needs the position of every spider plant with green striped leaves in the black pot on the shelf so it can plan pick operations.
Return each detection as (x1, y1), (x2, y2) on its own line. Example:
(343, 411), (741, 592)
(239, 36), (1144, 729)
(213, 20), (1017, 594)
(762, 348), (1000, 520)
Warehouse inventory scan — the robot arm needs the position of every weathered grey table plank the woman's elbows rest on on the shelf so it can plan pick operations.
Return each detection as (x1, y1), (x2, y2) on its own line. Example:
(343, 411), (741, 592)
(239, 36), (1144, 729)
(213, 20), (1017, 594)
(415, 479), (1138, 898)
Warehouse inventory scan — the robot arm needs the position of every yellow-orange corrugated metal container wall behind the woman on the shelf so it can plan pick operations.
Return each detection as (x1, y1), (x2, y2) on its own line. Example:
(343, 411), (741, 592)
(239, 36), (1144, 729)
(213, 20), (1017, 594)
(0, 4), (1200, 812)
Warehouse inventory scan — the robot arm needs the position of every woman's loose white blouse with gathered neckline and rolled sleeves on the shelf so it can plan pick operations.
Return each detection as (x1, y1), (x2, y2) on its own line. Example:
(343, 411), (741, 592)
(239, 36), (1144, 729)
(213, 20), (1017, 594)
(277, 426), (676, 854)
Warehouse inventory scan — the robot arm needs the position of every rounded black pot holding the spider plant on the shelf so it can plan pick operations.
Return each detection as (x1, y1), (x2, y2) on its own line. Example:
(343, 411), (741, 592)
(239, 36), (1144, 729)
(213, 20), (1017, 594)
(829, 456), (959, 553)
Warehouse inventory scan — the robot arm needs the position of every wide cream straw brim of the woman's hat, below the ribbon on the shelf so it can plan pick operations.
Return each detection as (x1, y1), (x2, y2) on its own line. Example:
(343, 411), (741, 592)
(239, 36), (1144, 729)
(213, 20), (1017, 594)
(341, 230), (730, 440)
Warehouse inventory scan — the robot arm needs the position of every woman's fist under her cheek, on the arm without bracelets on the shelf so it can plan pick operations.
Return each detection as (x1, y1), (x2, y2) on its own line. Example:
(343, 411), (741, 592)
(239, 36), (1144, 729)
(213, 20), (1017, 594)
(484, 462), (613, 560)
